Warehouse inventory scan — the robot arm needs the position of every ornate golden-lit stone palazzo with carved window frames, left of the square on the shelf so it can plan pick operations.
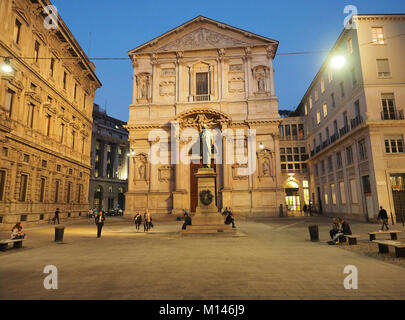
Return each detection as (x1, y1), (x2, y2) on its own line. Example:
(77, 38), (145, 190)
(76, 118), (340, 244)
(0, 0), (101, 229)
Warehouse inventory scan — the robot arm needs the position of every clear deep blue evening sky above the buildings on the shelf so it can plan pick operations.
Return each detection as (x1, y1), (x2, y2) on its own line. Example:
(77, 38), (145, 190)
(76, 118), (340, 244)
(51, 0), (405, 121)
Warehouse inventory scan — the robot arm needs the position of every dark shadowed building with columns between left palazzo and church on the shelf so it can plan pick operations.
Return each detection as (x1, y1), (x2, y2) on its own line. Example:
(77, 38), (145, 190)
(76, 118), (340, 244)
(89, 104), (129, 211)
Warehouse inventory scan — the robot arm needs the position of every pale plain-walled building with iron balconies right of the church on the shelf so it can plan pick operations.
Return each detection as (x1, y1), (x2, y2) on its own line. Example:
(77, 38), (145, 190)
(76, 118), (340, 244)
(297, 14), (405, 220)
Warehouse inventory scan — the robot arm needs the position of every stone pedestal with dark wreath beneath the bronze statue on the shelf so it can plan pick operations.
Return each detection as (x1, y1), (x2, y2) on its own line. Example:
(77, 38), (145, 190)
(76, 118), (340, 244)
(182, 168), (235, 233)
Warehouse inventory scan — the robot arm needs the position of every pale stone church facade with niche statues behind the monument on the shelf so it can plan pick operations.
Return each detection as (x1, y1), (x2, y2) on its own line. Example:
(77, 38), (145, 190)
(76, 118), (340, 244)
(126, 16), (285, 216)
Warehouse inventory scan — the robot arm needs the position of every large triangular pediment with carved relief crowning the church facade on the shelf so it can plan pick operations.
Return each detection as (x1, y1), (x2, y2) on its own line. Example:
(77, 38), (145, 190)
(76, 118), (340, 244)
(128, 16), (278, 55)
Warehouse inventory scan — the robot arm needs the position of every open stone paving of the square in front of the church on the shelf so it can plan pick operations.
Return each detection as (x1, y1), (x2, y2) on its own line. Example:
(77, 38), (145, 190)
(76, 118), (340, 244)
(0, 217), (405, 300)
